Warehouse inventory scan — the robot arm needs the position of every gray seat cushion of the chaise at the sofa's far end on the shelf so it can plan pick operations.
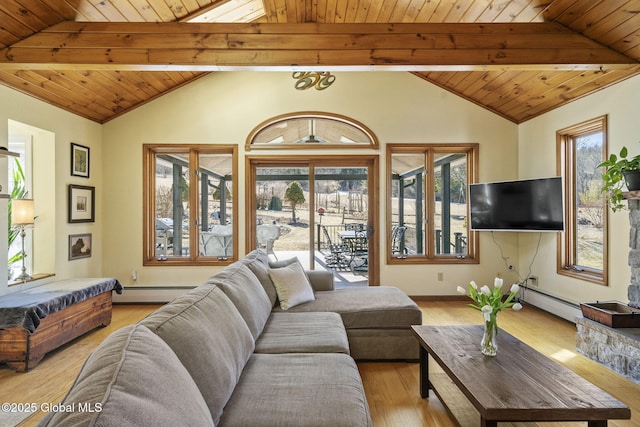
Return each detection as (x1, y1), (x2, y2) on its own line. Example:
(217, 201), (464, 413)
(274, 286), (422, 330)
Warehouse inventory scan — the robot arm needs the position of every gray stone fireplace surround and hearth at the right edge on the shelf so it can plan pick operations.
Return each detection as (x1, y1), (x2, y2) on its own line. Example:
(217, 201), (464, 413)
(575, 199), (640, 384)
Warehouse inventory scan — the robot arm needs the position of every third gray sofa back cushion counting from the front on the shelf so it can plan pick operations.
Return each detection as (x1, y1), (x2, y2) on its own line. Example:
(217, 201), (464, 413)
(207, 262), (273, 339)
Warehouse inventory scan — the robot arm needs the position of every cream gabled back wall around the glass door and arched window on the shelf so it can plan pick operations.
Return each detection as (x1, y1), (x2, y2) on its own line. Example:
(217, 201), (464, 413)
(103, 72), (518, 295)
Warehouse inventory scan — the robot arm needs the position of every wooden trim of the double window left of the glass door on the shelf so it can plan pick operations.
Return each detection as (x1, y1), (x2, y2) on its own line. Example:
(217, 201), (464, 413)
(142, 144), (239, 267)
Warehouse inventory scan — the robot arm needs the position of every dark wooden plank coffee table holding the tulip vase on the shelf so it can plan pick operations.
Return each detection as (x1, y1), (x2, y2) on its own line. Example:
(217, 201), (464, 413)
(412, 326), (631, 427)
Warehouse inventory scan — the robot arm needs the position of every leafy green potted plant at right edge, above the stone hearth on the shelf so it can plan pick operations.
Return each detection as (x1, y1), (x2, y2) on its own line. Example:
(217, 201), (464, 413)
(598, 147), (640, 212)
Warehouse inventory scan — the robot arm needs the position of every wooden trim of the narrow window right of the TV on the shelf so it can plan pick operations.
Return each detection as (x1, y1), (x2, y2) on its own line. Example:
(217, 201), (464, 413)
(556, 115), (609, 286)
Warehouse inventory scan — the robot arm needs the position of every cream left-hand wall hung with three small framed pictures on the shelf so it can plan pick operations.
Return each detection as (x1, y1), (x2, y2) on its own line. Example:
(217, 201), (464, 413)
(0, 86), (103, 295)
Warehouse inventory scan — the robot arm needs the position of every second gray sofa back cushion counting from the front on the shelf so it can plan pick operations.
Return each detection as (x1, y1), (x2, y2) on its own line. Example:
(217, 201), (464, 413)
(140, 285), (255, 424)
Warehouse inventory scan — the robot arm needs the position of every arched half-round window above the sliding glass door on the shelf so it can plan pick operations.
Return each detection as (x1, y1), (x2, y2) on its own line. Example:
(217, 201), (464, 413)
(246, 112), (378, 150)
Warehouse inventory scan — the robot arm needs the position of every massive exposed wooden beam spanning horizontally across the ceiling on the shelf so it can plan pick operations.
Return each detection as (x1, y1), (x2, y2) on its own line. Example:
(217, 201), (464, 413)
(0, 21), (638, 71)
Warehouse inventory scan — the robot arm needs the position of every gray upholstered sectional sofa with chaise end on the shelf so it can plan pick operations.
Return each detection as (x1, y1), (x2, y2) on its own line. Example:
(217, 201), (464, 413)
(40, 251), (422, 427)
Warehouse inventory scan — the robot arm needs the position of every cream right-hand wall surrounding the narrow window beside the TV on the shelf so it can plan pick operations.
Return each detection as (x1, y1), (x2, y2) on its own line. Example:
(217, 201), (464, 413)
(518, 77), (640, 302)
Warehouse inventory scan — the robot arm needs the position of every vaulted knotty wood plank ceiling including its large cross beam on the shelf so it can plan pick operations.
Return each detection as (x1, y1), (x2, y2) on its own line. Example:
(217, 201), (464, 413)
(0, 0), (640, 123)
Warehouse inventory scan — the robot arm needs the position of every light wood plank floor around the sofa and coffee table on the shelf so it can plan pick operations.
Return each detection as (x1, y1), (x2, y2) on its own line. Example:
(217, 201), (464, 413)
(0, 301), (640, 427)
